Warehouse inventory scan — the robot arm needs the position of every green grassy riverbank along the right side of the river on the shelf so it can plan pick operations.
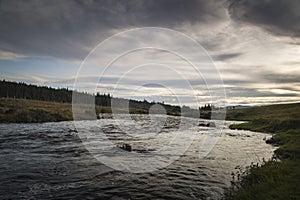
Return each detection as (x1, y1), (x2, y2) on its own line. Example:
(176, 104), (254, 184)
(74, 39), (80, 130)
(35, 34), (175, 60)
(227, 103), (300, 200)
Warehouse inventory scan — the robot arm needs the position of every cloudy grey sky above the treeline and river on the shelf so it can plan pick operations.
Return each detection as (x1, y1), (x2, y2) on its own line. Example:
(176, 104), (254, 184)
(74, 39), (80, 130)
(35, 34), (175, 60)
(0, 0), (300, 107)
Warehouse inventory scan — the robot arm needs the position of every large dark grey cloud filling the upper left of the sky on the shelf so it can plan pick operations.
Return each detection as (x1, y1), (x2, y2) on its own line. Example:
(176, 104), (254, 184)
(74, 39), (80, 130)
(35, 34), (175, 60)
(0, 0), (226, 60)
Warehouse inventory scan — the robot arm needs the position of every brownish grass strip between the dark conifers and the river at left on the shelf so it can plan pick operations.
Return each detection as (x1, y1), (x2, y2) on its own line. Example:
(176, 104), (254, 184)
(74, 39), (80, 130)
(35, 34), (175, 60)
(0, 98), (180, 123)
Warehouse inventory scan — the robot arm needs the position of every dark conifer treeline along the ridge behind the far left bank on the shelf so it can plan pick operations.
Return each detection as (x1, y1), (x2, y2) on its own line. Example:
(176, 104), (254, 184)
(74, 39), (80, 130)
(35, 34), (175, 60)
(0, 80), (180, 114)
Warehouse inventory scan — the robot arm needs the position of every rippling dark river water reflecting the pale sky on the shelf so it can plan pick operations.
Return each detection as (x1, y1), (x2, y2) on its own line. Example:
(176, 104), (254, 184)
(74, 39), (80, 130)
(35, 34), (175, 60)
(0, 115), (274, 199)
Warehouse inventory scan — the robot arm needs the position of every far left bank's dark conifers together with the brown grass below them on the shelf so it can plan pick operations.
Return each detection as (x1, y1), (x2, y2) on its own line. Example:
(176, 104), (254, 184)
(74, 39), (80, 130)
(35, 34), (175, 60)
(0, 80), (182, 122)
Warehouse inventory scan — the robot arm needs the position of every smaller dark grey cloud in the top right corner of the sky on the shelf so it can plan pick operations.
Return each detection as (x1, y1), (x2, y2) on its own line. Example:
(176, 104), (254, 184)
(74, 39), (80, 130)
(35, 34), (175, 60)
(229, 0), (300, 37)
